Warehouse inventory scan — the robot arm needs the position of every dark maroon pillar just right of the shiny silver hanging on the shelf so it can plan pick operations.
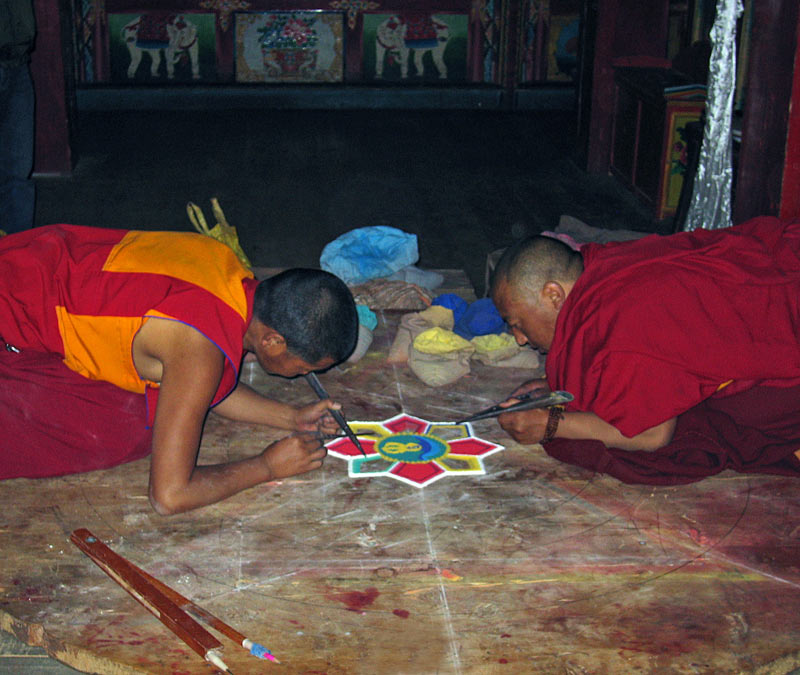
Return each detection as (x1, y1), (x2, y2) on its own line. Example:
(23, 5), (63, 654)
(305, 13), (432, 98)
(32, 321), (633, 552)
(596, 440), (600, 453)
(733, 0), (800, 224)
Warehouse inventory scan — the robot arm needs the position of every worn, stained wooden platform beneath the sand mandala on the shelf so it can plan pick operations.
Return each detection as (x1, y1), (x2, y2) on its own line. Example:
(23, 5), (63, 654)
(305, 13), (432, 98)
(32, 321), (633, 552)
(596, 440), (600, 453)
(0, 313), (800, 675)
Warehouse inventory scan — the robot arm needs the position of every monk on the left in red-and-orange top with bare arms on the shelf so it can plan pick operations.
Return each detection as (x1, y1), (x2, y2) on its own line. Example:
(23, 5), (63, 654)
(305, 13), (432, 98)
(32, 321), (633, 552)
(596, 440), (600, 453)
(0, 225), (358, 514)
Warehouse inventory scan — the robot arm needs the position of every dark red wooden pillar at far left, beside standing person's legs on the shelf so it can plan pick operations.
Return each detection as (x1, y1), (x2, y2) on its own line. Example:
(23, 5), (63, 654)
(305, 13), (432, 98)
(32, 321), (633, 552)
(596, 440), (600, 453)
(31, 0), (75, 174)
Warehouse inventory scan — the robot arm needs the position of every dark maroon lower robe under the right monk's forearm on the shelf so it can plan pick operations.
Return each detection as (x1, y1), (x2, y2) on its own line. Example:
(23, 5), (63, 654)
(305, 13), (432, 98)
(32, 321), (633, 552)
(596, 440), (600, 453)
(543, 386), (800, 485)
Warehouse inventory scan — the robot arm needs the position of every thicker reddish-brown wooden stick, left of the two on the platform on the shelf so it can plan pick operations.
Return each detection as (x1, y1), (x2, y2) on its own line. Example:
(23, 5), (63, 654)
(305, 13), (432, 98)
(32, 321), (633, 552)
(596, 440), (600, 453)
(70, 528), (231, 673)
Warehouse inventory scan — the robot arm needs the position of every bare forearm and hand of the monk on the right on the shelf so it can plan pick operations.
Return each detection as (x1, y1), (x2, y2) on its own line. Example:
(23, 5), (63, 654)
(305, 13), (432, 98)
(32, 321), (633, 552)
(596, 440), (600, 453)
(498, 410), (676, 451)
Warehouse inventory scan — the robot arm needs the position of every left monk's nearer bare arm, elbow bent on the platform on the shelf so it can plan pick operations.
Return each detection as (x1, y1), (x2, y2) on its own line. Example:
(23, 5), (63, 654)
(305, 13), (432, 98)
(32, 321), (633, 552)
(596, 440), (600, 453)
(137, 320), (325, 515)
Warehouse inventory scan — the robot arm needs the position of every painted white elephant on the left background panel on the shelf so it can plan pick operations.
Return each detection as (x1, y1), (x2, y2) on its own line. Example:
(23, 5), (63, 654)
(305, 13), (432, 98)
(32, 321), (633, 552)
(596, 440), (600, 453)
(122, 14), (200, 80)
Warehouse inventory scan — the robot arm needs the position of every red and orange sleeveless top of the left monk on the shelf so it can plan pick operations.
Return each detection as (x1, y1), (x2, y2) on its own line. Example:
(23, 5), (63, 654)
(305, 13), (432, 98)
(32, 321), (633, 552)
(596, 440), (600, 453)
(0, 225), (258, 426)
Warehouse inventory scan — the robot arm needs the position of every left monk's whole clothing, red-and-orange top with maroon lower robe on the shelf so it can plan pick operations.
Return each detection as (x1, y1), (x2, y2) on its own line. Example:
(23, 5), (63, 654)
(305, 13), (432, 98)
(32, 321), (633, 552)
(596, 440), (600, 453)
(0, 225), (257, 478)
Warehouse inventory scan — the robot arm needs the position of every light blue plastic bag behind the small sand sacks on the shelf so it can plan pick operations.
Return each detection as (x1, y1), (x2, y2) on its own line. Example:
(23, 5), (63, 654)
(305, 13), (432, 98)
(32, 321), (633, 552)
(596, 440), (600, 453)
(319, 225), (419, 285)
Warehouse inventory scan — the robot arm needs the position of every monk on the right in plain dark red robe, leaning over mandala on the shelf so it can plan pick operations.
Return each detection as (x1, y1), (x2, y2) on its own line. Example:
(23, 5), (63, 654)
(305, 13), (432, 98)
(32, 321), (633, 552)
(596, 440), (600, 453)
(491, 217), (800, 484)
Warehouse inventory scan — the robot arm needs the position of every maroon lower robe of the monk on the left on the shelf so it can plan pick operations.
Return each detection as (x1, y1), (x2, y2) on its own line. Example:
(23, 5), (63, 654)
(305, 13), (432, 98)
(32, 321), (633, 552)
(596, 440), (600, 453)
(0, 350), (152, 480)
